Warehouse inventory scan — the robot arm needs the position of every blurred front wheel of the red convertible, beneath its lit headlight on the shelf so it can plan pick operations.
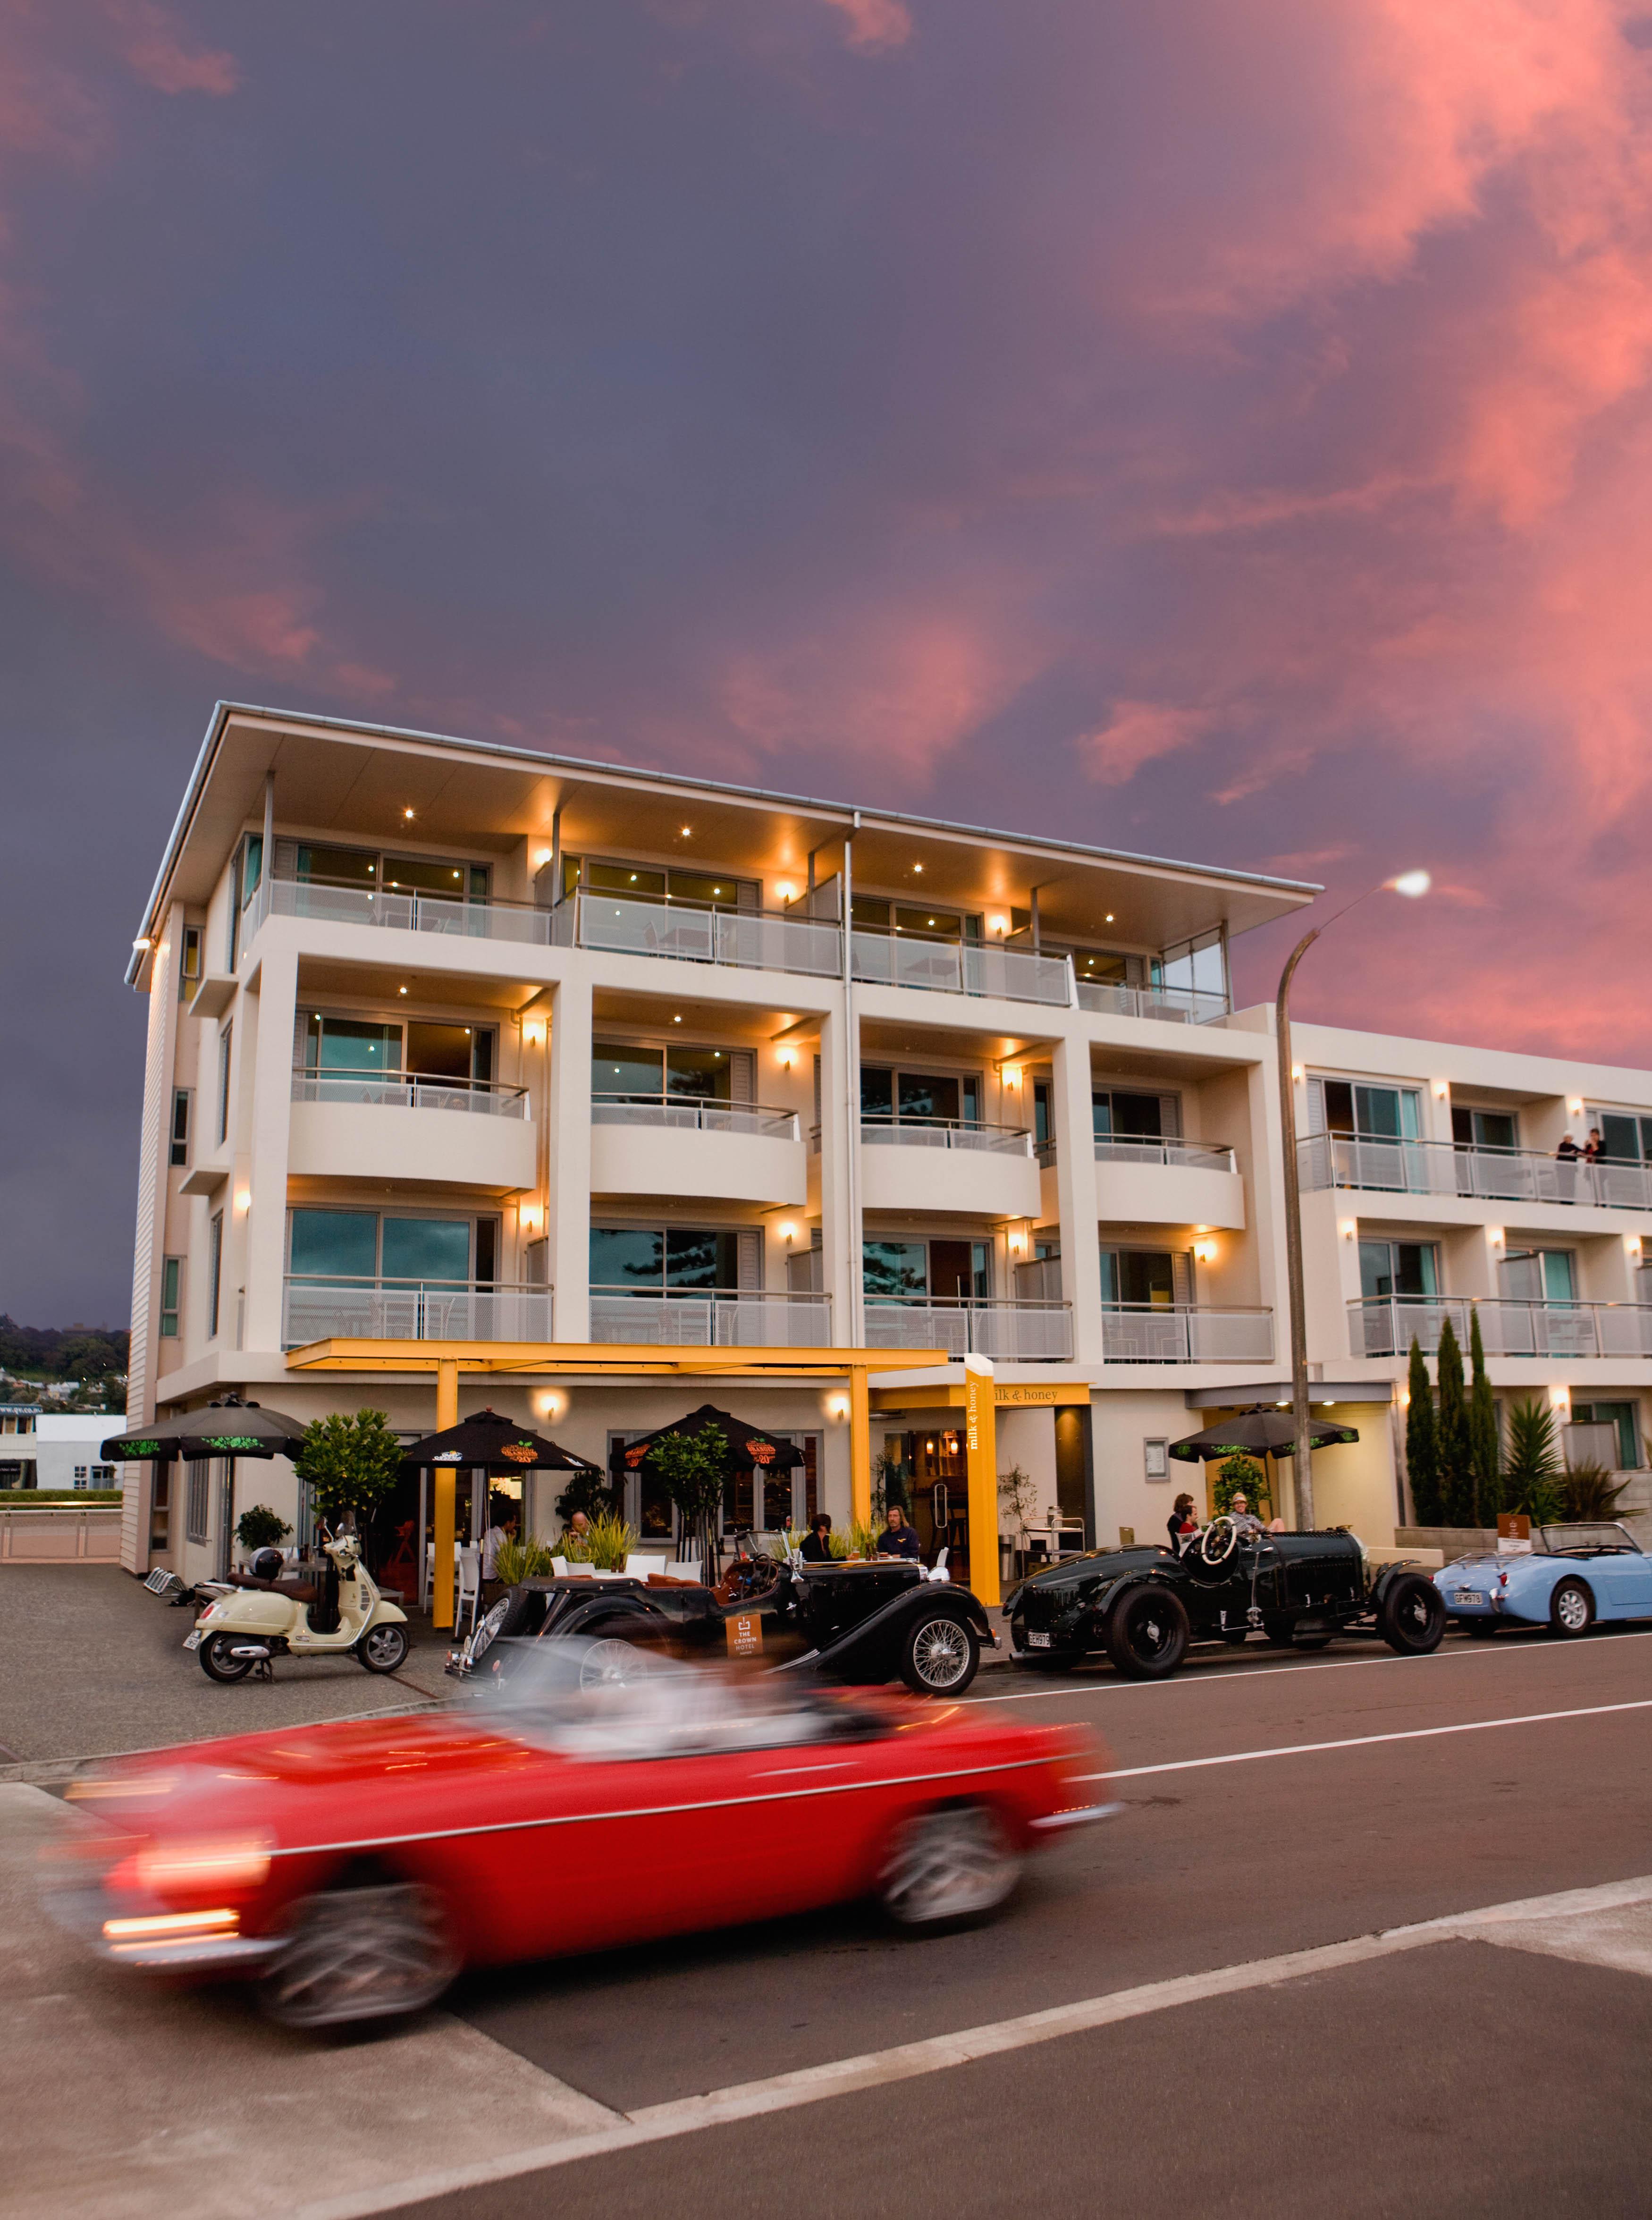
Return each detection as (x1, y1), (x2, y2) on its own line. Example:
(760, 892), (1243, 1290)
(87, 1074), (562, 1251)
(260, 1882), (460, 2027)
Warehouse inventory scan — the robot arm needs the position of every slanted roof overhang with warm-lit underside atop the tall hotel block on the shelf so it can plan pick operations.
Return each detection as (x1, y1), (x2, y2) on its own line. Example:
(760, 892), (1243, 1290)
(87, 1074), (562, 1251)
(131, 701), (1321, 983)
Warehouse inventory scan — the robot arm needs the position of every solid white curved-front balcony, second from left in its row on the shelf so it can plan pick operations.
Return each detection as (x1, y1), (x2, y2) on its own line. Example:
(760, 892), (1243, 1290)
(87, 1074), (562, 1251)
(590, 1095), (808, 1206)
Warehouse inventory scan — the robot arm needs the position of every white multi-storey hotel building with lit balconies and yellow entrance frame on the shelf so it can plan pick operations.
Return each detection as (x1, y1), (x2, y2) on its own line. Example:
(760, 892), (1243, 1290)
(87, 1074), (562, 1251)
(124, 706), (1652, 1587)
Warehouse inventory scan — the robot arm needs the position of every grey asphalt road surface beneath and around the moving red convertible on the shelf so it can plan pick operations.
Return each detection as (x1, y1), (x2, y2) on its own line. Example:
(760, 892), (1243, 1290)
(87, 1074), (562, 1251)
(0, 1632), (1652, 2220)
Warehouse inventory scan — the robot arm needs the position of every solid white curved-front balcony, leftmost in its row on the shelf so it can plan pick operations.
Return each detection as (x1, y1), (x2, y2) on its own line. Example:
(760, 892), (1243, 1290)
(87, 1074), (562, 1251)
(287, 1072), (535, 1194)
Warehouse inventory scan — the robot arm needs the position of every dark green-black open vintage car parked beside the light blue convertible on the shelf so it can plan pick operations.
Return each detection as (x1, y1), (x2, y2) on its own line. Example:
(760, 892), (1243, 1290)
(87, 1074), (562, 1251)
(1006, 1519), (1446, 1680)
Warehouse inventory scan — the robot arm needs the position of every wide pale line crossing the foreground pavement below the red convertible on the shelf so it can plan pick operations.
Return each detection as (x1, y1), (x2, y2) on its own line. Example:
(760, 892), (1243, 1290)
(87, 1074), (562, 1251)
(291, 1876), (1652, 2220)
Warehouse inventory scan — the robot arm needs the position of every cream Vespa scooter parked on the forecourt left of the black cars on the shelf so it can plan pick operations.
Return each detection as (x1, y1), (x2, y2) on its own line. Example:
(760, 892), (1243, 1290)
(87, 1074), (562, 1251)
(184, 1534), (406, 1680)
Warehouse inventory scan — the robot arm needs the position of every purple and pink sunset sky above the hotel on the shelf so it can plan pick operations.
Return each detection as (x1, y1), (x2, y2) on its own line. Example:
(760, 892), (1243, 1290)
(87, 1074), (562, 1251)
(0, 0), (1652, 1323)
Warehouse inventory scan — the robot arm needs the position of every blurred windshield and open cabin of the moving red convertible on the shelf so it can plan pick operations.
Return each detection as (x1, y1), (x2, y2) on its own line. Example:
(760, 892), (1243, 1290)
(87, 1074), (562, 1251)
(480, 1638), (886, 1760)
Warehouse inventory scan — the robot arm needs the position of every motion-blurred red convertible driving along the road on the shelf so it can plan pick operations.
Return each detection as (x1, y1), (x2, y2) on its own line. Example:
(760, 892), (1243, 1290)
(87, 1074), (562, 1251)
(49, 1643), (1108, 2027)
